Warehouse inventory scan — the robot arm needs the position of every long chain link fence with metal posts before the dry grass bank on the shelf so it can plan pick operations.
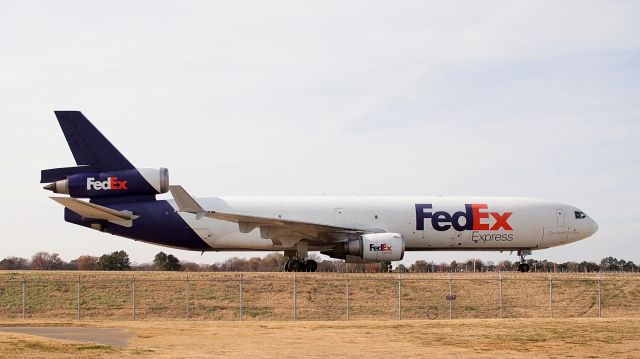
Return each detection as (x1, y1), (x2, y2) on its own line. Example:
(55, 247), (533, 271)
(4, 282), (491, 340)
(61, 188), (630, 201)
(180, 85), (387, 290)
(0, 272), (640, 320)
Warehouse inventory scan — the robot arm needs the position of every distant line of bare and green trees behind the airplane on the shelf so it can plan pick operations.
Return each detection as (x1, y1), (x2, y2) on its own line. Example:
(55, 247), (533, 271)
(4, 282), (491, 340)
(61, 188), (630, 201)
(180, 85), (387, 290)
(0, 251), (640, 273)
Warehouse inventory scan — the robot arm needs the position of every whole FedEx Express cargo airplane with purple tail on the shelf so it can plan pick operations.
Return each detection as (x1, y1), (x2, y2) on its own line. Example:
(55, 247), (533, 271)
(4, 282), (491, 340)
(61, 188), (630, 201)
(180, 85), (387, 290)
(41, 111), (598, 272)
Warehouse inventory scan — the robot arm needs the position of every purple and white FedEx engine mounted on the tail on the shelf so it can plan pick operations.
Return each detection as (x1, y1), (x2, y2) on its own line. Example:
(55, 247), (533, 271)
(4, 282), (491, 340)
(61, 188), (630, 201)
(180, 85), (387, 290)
(45, 168), (169, 198)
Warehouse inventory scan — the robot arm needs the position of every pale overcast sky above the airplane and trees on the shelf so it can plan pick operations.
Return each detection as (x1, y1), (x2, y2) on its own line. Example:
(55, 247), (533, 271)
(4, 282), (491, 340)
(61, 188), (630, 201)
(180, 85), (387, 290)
(0, 0), (640, 263)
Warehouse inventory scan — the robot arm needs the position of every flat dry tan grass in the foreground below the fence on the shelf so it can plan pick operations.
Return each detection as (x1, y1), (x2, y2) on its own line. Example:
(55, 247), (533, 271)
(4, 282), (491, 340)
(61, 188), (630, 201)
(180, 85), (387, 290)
(0, 318), (640, 358)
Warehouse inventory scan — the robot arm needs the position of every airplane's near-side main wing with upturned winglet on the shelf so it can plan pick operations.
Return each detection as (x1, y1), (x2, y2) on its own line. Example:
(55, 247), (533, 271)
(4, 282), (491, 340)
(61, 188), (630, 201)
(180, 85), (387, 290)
(169, 186), (372, 247)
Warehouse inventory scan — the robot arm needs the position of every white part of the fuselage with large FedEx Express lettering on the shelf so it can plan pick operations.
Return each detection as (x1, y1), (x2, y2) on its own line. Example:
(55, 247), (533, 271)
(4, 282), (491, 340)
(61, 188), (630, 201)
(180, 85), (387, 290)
(171, 196), (597, 251)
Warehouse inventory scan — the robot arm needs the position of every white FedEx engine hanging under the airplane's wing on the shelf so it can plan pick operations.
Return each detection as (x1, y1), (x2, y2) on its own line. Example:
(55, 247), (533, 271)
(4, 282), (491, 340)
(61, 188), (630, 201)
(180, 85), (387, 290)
(323, 233), (404, 262)
